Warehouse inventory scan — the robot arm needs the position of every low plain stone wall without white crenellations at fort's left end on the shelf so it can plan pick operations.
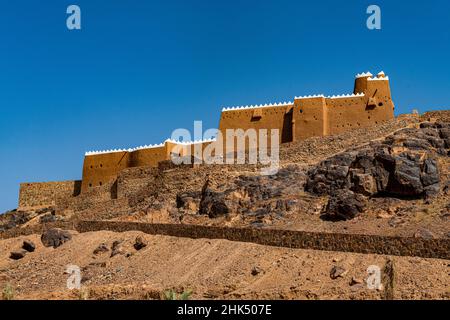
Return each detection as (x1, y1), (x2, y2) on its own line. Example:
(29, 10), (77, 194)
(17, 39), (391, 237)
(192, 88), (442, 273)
(19, 180), (81, 209)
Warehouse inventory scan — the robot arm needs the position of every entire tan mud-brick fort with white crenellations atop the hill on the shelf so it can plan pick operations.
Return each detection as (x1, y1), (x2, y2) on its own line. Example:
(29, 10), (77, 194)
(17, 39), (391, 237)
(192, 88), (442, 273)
(19, 72), (394, 208)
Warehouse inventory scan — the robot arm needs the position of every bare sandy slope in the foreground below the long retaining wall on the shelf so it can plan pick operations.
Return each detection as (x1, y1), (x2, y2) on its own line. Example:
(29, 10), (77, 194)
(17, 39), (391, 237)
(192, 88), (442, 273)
(0, 231), (450, 299)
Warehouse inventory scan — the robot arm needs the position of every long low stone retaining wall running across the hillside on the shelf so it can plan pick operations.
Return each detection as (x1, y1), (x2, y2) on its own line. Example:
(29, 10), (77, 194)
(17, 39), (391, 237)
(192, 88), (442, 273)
(0, 221), (450, 259)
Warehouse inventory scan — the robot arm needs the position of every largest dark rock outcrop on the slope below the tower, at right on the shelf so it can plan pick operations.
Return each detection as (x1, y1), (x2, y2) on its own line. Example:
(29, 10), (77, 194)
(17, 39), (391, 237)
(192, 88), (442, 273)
(306, 123), (449, 198)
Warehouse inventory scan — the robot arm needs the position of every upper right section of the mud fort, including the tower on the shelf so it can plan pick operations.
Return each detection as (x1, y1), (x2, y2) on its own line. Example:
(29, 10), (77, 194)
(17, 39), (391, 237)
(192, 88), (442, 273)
(219, 72), (394, 143)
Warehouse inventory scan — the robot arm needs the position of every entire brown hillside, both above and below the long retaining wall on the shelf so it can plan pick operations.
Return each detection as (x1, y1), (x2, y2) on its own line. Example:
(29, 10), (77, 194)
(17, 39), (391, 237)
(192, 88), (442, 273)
(0, 111), (450, 299)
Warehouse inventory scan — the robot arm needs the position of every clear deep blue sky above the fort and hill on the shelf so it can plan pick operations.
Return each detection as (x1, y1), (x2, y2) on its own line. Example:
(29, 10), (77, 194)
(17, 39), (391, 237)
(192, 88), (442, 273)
(0, 0), (450, 211)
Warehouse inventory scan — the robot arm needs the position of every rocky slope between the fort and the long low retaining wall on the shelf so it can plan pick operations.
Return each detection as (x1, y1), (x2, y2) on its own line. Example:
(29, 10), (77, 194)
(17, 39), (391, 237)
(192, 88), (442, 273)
(0, 111), (450, 236)
